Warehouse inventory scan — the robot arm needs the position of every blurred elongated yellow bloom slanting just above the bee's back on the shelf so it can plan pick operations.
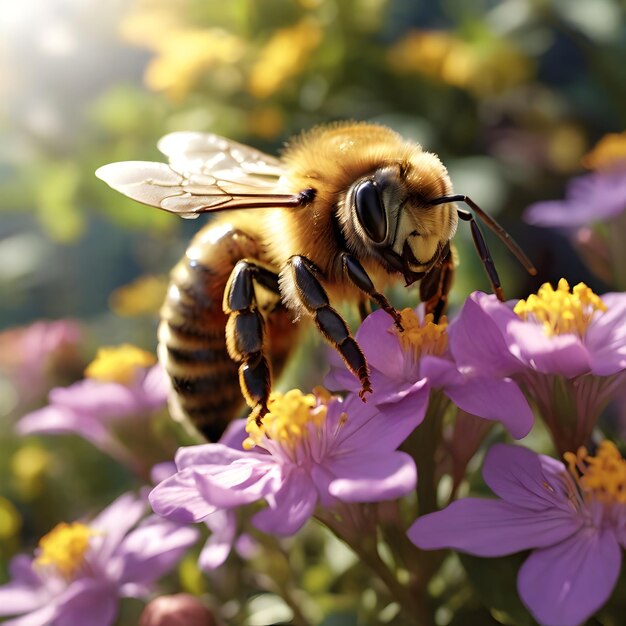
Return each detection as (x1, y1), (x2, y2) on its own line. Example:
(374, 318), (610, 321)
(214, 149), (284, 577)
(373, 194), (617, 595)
(248, 18), (324, 100)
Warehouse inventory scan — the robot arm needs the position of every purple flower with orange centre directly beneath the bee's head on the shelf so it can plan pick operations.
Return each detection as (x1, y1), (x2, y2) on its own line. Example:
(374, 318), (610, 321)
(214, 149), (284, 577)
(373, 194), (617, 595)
(325, 309), (533, 439)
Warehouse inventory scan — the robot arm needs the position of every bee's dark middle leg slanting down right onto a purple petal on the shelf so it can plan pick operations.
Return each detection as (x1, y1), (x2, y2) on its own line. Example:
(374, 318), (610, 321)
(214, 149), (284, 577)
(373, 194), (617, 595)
(284, 256), (372, 400)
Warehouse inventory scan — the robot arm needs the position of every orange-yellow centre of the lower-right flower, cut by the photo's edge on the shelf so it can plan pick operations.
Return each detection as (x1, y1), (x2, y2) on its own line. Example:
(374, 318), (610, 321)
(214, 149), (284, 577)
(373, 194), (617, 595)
(564, 441), (626, 504)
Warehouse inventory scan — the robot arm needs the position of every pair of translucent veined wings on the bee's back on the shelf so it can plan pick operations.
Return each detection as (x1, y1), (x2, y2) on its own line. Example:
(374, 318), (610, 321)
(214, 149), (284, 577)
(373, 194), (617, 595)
(96, 132), (305, 217)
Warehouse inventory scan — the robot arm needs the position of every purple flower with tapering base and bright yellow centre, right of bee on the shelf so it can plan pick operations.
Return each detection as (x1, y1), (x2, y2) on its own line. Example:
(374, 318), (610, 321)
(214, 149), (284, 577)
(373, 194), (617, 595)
(450, 279), (626, 452)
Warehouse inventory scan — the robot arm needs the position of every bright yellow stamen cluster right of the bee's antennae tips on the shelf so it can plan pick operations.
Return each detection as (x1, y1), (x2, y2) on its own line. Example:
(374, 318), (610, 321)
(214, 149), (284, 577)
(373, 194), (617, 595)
(513, 278), (607, 338)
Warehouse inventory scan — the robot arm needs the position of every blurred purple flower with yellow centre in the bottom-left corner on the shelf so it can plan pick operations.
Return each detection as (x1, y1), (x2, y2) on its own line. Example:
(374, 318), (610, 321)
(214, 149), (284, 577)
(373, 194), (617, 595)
(0, 494), (198, 626)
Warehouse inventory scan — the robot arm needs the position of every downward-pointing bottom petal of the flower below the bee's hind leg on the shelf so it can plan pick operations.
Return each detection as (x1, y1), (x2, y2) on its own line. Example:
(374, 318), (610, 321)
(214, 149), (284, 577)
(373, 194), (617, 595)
(252, 469), (318, 536)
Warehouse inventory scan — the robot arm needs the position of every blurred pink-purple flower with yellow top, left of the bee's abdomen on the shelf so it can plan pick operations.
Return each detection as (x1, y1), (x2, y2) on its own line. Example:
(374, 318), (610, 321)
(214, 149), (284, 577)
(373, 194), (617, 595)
(17, 346), (173, 469)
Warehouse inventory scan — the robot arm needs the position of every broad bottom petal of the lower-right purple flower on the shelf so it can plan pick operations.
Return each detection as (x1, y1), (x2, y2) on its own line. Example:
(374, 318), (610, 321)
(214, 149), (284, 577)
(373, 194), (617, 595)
(518, 527), (621, 626)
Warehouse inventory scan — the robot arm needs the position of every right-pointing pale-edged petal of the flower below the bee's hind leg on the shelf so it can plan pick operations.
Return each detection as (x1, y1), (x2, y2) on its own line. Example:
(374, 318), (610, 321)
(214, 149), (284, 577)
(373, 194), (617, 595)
(329, 452), (417, 502)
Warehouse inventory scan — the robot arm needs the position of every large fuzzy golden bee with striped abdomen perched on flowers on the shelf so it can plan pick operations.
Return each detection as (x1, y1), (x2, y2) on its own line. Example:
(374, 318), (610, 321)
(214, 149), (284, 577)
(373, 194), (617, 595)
(96, 122), (535, 441)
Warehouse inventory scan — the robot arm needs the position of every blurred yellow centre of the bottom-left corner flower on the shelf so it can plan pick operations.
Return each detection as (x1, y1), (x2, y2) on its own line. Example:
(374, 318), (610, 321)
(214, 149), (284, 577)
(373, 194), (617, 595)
(35, 522), (94, 579)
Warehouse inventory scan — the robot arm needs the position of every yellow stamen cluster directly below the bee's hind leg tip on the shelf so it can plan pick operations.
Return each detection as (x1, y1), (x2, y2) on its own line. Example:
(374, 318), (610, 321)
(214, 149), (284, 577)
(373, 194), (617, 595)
(243, 389), (330, 450)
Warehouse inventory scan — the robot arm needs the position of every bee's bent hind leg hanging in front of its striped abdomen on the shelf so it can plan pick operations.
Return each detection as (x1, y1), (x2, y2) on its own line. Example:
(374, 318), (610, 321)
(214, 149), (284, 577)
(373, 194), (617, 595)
(223, 259), (280, 425)
